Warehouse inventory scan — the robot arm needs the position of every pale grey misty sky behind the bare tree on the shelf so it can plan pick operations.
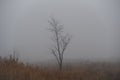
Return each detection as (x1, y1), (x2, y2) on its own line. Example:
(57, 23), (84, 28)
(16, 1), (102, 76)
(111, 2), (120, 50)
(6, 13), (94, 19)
(0, 0), (120, 61)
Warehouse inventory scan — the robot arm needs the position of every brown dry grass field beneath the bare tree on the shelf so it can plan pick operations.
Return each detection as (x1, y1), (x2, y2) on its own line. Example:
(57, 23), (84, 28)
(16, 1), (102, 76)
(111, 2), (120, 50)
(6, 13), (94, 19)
(0, 59), (120, 80)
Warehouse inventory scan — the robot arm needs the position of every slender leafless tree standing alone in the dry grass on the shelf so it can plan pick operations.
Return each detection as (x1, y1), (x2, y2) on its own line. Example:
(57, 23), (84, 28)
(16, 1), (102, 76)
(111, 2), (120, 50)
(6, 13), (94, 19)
(48, 18), (71, 70)
